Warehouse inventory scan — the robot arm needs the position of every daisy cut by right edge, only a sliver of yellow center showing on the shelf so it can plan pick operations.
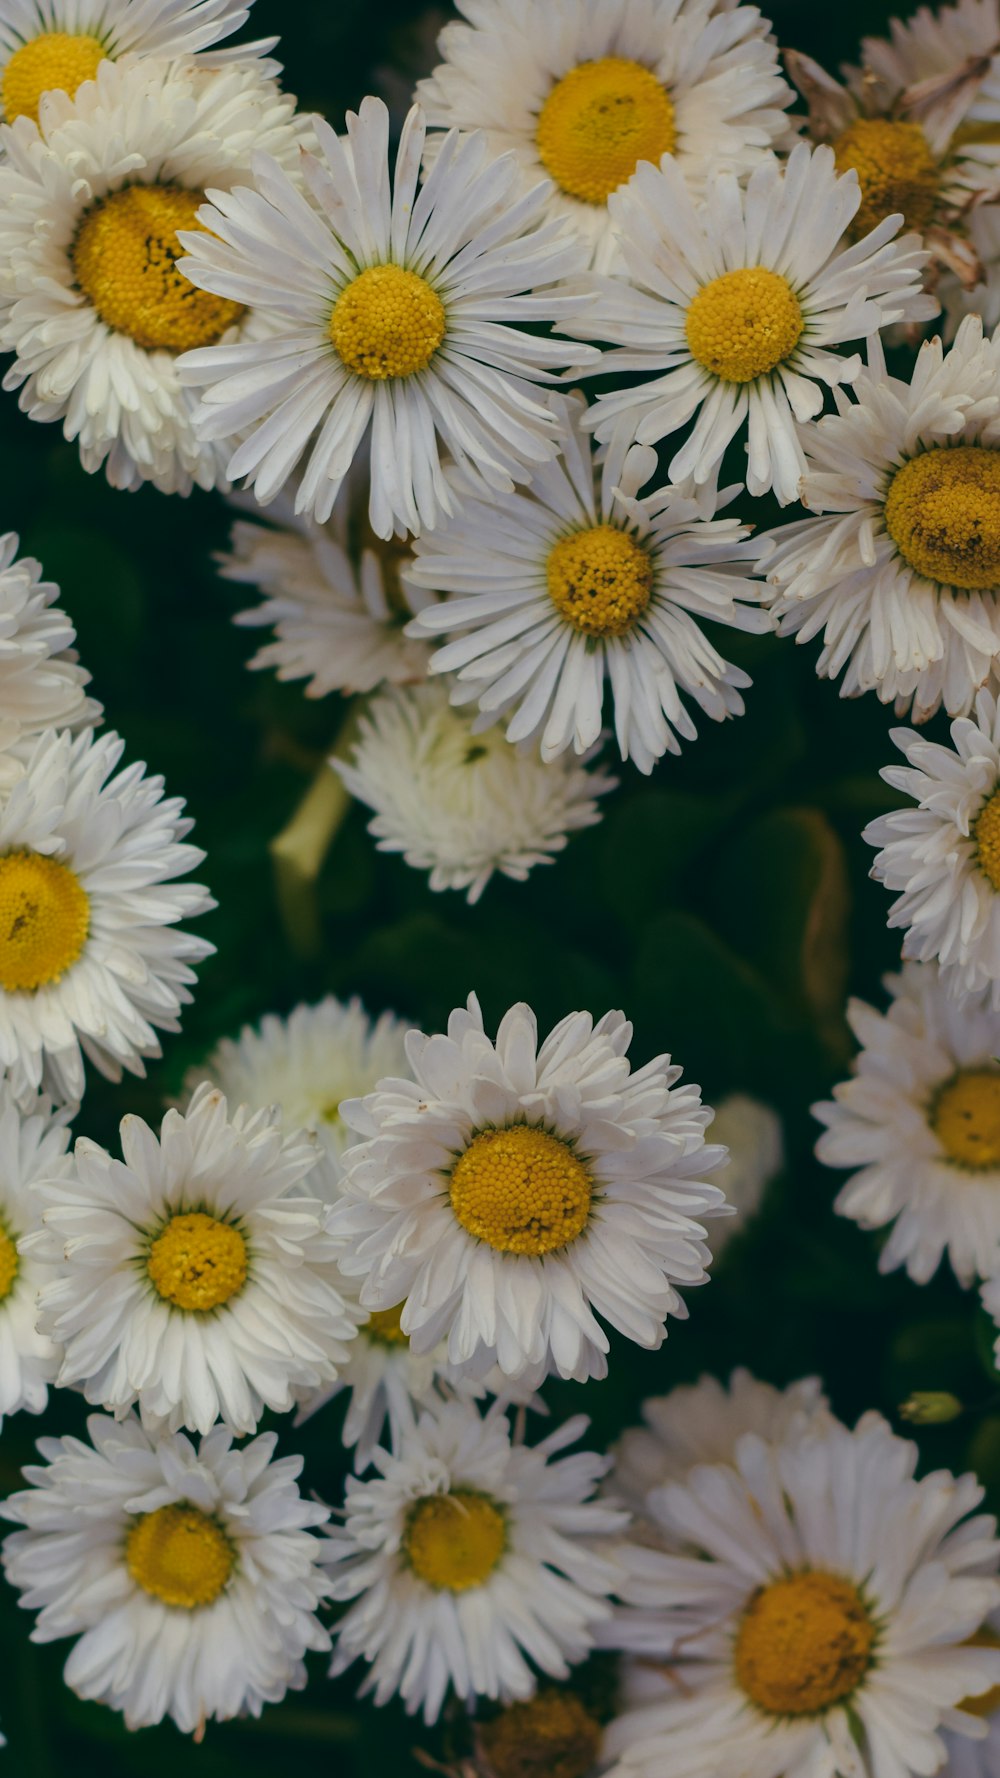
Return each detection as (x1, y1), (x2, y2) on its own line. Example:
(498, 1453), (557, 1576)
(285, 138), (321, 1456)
(863, 692), (1000, 1010)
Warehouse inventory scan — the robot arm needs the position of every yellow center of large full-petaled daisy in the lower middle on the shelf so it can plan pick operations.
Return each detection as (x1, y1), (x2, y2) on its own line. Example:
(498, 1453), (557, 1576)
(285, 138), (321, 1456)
(450, 1124), (594, 1253)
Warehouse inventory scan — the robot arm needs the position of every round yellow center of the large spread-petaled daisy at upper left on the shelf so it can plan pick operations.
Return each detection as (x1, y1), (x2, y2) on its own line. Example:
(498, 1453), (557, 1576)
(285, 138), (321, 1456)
(329, 265), (445, 382)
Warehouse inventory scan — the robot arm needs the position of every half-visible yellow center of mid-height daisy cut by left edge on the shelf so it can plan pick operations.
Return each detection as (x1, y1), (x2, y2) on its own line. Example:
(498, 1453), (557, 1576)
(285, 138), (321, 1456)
(0, 852), (91, 994)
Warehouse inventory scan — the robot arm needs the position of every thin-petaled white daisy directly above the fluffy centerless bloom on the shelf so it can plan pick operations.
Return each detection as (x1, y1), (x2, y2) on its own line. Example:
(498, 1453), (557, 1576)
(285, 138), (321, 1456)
(407, 400), (770, 772)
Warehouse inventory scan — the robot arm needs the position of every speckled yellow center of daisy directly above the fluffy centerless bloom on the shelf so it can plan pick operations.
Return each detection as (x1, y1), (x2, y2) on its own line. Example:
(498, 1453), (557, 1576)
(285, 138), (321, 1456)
(544, 525), (653, 637)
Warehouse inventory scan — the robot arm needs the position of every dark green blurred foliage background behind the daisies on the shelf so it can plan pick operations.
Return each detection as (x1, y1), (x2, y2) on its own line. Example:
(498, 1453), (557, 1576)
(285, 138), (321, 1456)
(0, 0), (1000, 1778)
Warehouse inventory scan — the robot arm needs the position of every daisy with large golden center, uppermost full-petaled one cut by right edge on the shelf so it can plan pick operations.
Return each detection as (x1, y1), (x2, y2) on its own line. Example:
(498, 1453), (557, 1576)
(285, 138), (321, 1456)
(767, 327), (1000, 722)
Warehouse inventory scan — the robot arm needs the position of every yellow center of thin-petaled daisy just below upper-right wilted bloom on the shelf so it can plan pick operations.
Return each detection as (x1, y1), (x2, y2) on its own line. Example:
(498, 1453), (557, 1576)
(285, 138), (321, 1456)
(685, 265), (806, 382)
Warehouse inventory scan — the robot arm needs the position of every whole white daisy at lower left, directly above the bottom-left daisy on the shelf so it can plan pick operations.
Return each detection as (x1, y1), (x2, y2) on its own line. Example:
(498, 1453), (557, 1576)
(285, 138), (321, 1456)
(28, 1085), (356, 1433)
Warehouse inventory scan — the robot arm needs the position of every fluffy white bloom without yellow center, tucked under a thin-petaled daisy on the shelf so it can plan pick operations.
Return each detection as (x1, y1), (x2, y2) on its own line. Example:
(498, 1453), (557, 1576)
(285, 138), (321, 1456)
(331, 683), (617, 901)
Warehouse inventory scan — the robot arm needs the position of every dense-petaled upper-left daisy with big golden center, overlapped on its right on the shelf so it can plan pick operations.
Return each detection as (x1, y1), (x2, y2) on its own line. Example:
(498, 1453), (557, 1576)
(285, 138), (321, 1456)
(0, 60), (306, 494)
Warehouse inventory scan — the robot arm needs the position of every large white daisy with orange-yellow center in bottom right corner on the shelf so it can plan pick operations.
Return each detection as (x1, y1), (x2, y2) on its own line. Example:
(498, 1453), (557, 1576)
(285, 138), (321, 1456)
(607, 1414), (1000, 1778)
